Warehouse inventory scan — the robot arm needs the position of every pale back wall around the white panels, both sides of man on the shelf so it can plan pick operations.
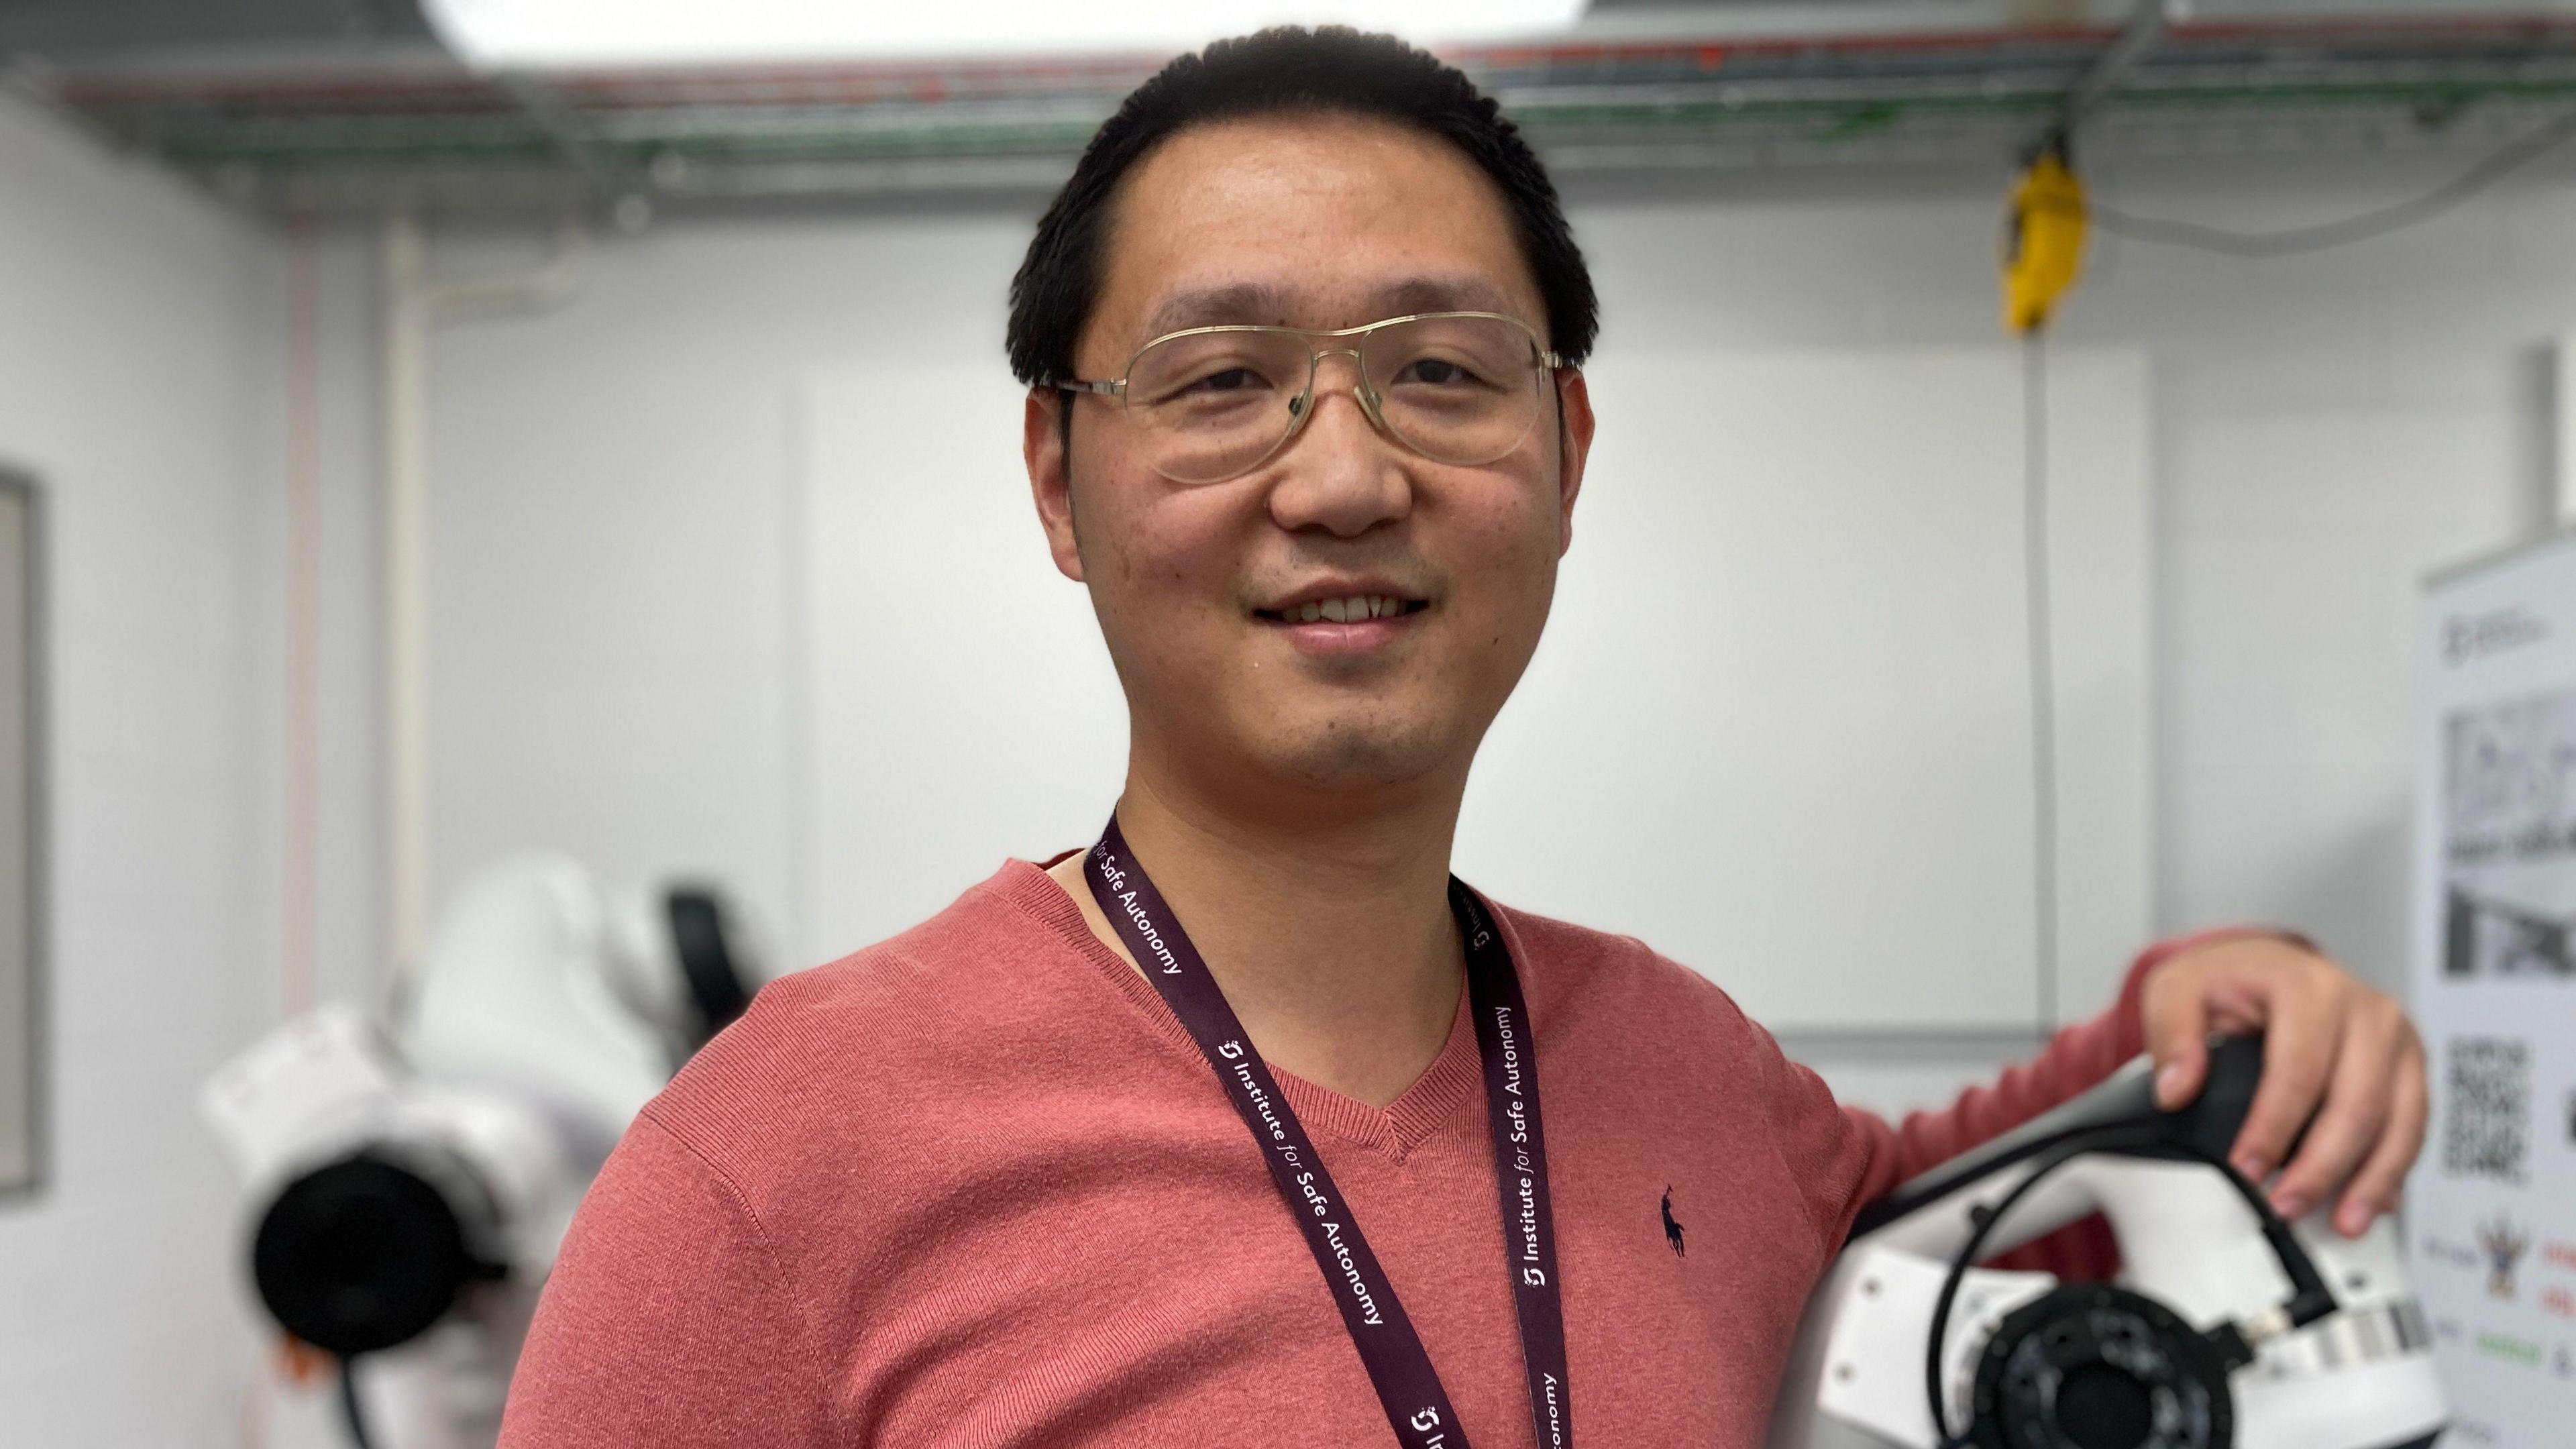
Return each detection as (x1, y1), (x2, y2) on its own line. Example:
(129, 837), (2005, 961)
(407, 160), (2576, 1101)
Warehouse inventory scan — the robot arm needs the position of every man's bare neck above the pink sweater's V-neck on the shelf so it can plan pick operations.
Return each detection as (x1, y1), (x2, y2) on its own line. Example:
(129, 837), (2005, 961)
(1054, 761), (1466, 1106)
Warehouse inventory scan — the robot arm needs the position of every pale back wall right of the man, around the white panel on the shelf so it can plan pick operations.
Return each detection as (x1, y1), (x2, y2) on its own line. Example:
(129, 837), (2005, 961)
(1582, 160), (2544, 1005)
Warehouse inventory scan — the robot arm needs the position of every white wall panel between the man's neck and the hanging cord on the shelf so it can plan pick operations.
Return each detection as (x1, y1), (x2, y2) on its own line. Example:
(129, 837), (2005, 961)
(1458, 348), (2071, 1026)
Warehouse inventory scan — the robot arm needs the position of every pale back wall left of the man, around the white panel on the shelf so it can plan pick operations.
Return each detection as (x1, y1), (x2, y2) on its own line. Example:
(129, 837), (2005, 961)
(427, 214), (1040, 972)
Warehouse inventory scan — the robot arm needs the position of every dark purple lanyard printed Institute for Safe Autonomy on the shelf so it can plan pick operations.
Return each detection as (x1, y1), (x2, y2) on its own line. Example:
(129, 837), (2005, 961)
(1082, 815), (1574, 1449)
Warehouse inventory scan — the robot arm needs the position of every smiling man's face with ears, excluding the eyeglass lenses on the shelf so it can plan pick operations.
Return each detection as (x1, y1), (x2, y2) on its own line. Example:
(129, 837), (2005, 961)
(1025, 116), (1592, 814)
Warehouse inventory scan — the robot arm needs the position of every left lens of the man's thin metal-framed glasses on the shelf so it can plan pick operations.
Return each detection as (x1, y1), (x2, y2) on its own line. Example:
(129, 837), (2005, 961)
(1126, 330), (1313, 482)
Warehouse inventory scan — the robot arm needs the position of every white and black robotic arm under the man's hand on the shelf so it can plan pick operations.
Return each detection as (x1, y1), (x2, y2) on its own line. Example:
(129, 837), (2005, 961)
(1770, 1039), (2447, 1449)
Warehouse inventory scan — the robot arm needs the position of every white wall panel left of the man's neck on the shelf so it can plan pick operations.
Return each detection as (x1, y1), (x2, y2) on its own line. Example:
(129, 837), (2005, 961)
(804, 364), (1126, 962)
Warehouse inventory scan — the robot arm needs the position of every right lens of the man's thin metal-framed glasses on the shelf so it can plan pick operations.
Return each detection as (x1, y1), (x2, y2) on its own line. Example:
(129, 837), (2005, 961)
(1362, 317), (1540, 467)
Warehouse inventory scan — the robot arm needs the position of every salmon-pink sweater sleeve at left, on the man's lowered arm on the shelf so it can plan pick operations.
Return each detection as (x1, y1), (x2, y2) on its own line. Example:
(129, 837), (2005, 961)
(500, 1109), (829, 1449)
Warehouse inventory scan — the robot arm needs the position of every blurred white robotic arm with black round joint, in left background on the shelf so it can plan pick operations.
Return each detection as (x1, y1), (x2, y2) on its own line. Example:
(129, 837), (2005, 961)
(201, 856), (752, 1449)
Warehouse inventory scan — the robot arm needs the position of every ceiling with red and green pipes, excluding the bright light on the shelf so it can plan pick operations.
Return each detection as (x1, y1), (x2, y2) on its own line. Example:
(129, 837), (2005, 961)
(0, 0), (2576, 219)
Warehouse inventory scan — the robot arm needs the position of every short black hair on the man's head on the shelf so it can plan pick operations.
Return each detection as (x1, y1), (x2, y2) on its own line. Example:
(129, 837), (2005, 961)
(1010, 25), (1600, 387)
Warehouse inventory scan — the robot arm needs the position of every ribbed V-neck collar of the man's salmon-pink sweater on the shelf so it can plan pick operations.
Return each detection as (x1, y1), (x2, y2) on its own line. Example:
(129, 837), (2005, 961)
(1000, 861), (1484, 1163)
